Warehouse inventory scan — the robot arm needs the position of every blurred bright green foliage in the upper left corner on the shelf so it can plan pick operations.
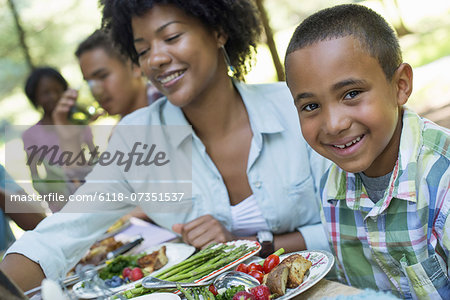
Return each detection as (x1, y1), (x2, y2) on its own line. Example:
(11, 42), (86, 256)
(0, 0), (100, 99)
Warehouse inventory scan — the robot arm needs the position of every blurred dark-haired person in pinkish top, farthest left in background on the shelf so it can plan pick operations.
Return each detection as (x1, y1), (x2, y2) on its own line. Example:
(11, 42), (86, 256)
(22, 67), (95, 212)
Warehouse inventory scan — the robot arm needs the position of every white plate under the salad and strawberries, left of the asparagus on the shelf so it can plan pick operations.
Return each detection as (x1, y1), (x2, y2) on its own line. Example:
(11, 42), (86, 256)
(72, 243), (195, 299)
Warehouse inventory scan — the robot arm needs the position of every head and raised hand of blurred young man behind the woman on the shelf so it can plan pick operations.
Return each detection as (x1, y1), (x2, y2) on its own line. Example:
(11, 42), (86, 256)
(53, 29), (162, 124)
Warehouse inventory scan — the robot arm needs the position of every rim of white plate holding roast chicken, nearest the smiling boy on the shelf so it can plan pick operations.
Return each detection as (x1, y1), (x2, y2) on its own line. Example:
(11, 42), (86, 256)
(276, 250), (334, 300)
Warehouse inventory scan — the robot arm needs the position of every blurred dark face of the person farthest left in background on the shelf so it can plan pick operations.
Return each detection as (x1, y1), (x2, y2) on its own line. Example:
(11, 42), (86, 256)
(36, 76), (64, 114)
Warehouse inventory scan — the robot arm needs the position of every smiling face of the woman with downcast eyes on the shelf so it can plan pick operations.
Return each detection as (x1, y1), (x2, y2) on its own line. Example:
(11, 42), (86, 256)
(132, 5), (227, 107)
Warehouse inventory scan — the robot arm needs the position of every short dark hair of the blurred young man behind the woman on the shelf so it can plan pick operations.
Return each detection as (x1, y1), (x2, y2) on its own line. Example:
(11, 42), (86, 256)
(75, 29), (128, 64)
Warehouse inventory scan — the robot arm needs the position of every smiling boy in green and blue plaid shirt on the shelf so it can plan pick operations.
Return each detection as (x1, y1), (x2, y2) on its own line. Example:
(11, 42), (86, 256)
(285, 5), (450, 299)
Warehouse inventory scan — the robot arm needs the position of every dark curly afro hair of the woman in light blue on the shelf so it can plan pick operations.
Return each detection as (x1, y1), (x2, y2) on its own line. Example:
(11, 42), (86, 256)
(100, 0), (262, 80)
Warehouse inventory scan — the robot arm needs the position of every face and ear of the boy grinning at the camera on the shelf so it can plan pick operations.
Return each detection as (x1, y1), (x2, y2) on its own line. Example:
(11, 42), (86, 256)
(286, 36), (412, 177)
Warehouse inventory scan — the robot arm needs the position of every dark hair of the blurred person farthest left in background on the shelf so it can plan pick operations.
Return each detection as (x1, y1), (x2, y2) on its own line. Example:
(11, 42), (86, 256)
(25, 67), (68, 108)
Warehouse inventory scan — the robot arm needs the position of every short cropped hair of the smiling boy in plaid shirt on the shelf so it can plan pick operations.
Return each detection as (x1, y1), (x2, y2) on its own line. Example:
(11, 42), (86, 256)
(286, 4), (402, 80)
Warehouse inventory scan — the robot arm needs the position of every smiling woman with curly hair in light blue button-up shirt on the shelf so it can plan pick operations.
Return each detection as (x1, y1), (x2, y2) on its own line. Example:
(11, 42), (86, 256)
(3, 0), (327, 287)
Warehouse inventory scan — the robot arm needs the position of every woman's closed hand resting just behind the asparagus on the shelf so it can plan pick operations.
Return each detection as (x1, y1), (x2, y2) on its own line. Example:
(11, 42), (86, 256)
(172, 215), (236, 249)
